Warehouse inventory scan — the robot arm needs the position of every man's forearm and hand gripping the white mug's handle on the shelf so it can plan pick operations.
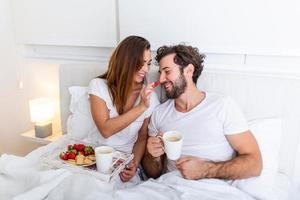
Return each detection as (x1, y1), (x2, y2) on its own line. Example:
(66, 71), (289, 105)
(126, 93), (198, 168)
(142, 137), (165, 178)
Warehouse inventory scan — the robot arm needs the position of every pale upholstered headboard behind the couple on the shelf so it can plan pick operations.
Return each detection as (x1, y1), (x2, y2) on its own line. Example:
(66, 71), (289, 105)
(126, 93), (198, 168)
(59, 64), (300, 181)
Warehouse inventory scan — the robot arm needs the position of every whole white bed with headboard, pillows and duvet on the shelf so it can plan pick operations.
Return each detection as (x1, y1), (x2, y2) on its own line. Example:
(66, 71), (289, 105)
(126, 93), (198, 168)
(0, 63), (300, 200)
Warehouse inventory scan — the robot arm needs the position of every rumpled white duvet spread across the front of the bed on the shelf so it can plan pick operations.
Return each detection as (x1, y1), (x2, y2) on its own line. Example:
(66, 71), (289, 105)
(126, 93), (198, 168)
(0, 136), (254, 200)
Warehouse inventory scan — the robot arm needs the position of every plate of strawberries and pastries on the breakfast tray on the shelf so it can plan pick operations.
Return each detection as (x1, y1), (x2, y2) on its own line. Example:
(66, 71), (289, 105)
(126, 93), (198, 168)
(59, 144), (96, 166)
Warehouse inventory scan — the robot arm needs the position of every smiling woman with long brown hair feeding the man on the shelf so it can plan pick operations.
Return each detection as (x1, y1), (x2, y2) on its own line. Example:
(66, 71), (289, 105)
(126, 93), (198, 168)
(89, 36), (159, 182)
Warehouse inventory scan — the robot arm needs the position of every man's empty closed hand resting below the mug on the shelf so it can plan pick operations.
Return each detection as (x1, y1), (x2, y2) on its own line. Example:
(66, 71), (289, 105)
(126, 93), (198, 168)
(176, 156), (211, 180)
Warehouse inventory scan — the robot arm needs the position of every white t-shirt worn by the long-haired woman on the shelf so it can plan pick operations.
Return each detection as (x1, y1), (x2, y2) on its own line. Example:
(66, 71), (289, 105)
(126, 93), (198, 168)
(88, 78), (159, 153)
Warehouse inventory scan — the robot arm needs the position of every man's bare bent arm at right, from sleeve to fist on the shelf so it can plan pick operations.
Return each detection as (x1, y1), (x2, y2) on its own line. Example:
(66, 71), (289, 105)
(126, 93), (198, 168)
(176, 131), (262, 179)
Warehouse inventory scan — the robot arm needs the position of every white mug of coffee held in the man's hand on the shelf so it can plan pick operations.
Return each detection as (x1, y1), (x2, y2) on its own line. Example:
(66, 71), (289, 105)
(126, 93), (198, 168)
(158, 131), (183, 160)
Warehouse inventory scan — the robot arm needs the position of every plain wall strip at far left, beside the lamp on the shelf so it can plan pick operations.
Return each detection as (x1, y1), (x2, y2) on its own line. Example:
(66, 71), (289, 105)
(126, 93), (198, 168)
(0, 0), (41, 155)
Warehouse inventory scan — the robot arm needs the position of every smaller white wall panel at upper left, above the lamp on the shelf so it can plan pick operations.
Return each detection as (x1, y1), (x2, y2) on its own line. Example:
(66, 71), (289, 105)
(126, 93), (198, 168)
(11, 0), (117, 47)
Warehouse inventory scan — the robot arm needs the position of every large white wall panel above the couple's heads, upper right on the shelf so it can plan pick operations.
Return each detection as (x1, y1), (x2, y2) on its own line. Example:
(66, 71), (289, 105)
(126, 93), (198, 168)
(119, 0), (300, 56)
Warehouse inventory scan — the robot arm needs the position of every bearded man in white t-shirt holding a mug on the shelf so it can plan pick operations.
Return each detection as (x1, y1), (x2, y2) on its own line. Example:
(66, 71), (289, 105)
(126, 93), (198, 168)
(143, 45), (262, 180)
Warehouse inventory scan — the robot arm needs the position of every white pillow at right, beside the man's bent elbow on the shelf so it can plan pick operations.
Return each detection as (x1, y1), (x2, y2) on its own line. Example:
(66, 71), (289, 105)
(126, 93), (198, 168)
(233, 118), (282, 200)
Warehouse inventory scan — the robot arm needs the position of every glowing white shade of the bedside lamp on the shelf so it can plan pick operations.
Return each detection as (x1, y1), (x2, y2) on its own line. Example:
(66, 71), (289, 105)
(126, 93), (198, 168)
(29, 98), (54, 125)
